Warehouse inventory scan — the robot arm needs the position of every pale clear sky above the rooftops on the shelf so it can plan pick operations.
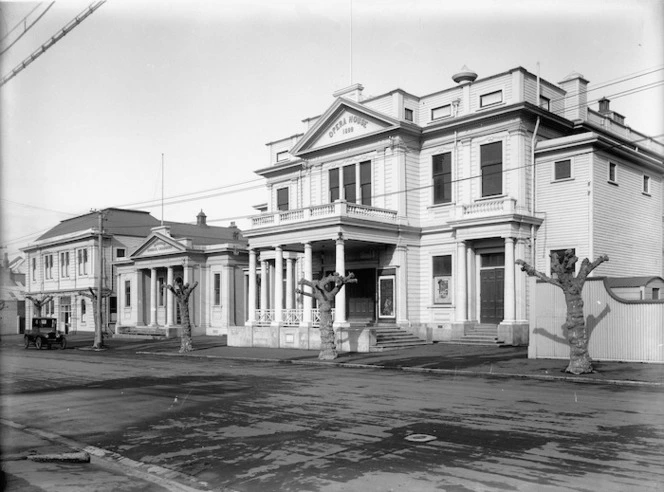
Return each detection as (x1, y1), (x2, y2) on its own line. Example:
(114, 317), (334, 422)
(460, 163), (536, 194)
(0, 0), (664, 257)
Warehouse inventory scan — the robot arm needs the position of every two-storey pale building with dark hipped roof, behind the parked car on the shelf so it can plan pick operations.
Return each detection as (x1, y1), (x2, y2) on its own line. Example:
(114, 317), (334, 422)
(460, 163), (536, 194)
(23, 208), (165, 332)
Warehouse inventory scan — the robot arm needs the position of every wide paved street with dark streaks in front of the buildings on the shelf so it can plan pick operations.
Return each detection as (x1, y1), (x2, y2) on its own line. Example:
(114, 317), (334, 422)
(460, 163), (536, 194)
(1, 350), (664, 491)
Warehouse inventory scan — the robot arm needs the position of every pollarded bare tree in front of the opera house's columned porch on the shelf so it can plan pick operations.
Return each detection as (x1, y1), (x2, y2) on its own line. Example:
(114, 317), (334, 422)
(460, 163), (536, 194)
(296, 272), (357, 360)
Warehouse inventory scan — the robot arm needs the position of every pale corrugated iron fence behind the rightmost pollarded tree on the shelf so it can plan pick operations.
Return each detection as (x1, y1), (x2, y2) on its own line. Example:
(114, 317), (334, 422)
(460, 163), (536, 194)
(528, 278), (664, 362)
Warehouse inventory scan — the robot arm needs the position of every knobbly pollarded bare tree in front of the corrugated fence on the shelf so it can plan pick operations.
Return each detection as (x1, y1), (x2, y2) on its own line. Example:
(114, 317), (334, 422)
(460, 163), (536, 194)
(516, 249), (609, 374)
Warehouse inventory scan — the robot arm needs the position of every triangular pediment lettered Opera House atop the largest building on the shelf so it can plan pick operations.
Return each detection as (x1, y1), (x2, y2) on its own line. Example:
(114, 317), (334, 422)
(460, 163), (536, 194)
(291, 98), (399, 155)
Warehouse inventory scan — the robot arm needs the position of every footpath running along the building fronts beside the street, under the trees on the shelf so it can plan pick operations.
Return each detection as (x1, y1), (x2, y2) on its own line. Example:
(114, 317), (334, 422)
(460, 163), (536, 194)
(0, 333), (664, 388)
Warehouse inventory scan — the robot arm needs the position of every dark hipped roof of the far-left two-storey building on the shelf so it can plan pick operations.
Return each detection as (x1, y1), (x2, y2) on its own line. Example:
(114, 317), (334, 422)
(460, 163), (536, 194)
(37, 208), (159, 241)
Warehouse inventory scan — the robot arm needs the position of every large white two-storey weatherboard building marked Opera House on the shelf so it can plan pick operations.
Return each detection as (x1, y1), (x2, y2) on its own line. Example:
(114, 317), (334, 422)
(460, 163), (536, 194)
(229, 67), (664, 358)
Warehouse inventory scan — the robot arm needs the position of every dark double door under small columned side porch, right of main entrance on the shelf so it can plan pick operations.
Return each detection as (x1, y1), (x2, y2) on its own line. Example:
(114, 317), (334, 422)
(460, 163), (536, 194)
(480, 253), (505, 324)
